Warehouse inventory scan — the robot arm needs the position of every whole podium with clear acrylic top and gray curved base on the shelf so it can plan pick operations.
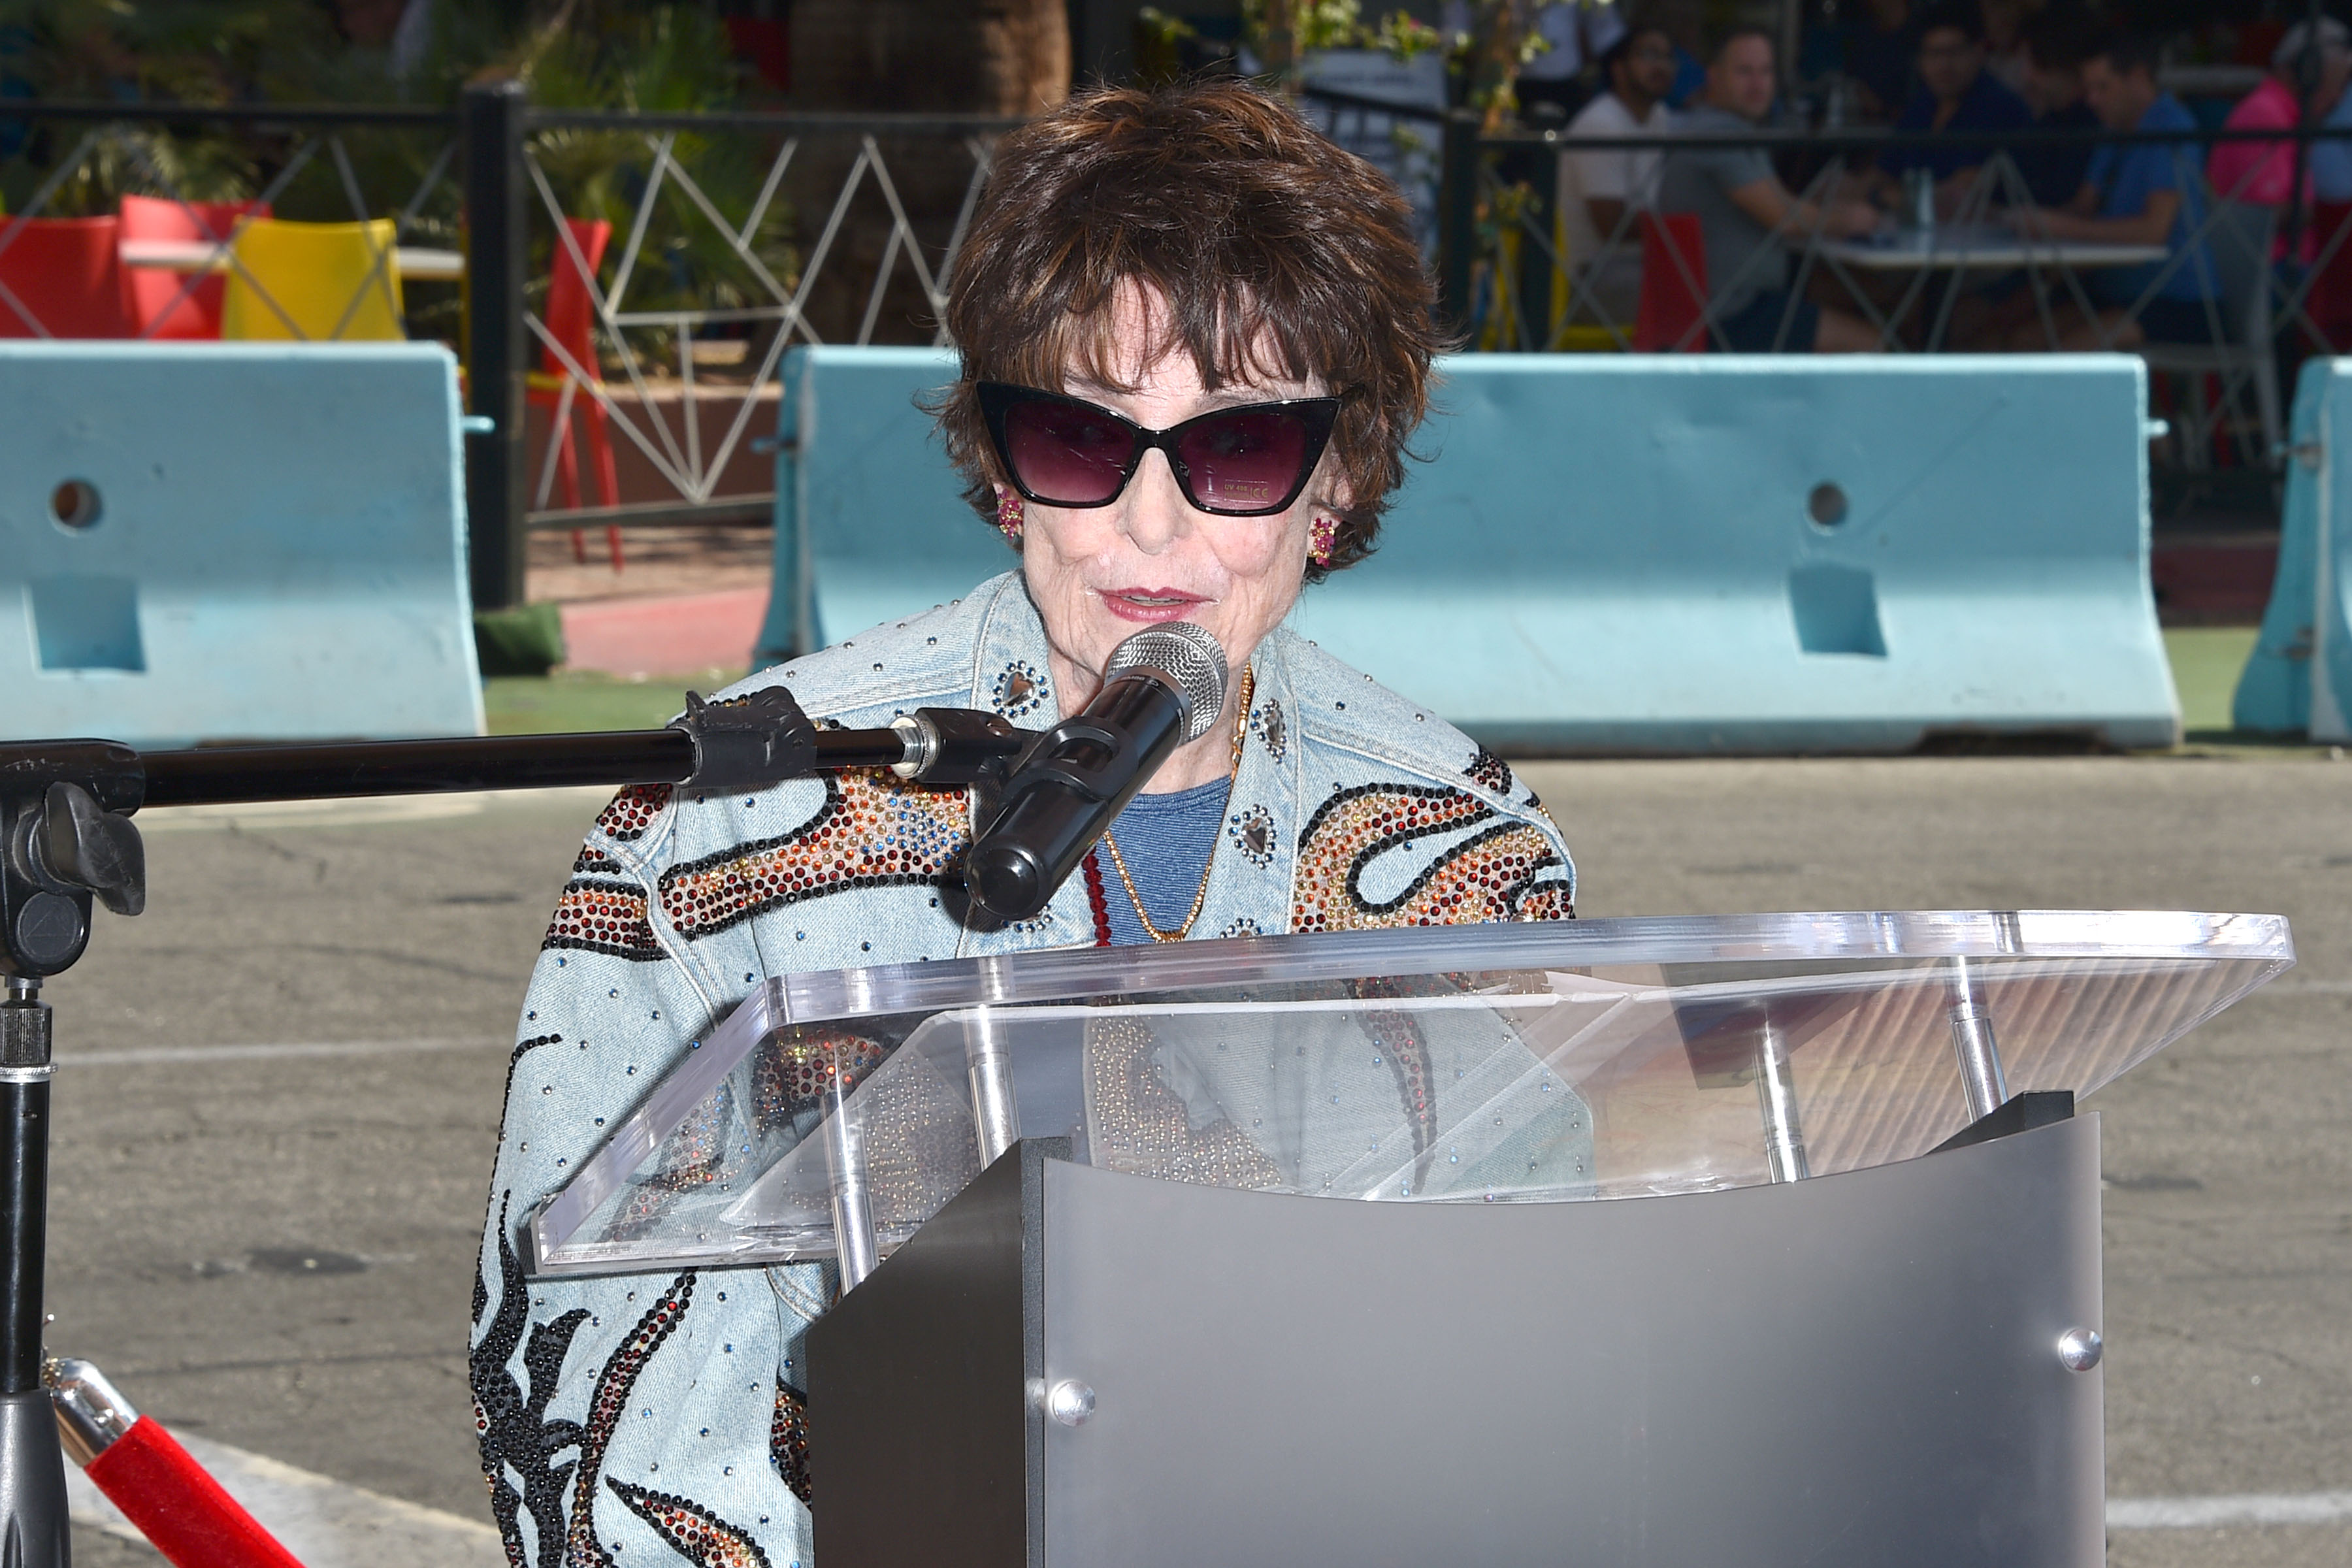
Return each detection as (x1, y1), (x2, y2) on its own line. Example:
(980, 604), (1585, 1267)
(529, 910), (2293, 1568)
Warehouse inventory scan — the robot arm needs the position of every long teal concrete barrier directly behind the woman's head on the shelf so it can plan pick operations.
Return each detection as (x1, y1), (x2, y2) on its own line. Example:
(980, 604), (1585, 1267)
(764, 350), (2180, 752)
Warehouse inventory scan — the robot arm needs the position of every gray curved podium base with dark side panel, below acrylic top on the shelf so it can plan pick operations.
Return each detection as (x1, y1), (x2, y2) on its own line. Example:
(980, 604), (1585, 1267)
(809, 1117), (2105, 1568)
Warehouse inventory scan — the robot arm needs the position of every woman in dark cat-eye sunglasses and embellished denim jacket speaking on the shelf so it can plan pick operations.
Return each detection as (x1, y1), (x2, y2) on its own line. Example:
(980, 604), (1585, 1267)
(473, 85), (1573, 1568)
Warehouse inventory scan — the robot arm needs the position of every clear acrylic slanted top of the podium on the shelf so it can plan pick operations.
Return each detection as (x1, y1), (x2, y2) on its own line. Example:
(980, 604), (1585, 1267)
(529, 910), (2293, 1274)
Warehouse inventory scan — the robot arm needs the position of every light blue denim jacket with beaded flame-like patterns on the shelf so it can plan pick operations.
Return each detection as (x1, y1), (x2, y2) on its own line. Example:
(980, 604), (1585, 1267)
(470, 574), (1573, 1568)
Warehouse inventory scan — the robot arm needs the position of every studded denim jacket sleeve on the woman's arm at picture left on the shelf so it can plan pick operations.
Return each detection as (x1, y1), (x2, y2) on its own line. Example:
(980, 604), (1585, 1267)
(468, 792), (830, 1568)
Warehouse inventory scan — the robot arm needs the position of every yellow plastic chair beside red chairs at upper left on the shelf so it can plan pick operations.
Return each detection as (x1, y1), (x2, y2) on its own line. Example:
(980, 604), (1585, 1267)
(221, 219), (407, 343)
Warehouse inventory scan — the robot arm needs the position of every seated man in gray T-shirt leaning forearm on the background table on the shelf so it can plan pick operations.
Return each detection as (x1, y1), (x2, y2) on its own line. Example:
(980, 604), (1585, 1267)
(1644, 28), (1879, 353)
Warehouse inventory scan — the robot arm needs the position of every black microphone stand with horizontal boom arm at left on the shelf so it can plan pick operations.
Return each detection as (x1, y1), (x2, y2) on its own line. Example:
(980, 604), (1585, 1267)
(0, 687), (1030, 1568)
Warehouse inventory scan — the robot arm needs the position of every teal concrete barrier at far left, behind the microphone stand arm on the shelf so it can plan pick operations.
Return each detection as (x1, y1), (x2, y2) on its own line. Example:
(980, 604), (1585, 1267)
(0, 341), (482, 747)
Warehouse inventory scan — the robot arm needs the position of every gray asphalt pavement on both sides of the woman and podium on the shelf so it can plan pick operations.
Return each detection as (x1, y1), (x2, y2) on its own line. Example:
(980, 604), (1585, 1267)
(47, 752), (2352, 1568)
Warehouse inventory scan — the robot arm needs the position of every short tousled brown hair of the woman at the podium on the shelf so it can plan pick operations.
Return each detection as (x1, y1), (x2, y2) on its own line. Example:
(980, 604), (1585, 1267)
(936, 80), (1439, 581)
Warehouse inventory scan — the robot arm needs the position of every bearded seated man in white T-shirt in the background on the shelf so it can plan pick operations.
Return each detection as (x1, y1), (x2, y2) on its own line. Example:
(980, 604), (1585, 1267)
(1560, 24), (1674, 322)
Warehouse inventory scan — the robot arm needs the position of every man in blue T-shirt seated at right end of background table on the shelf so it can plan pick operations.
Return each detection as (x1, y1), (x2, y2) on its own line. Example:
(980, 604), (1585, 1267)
(2008, 33), (2215, 348)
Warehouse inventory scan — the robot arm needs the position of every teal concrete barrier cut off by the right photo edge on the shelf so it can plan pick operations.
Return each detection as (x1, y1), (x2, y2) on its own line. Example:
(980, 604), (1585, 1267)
(2230, 360), (2352, 740)
